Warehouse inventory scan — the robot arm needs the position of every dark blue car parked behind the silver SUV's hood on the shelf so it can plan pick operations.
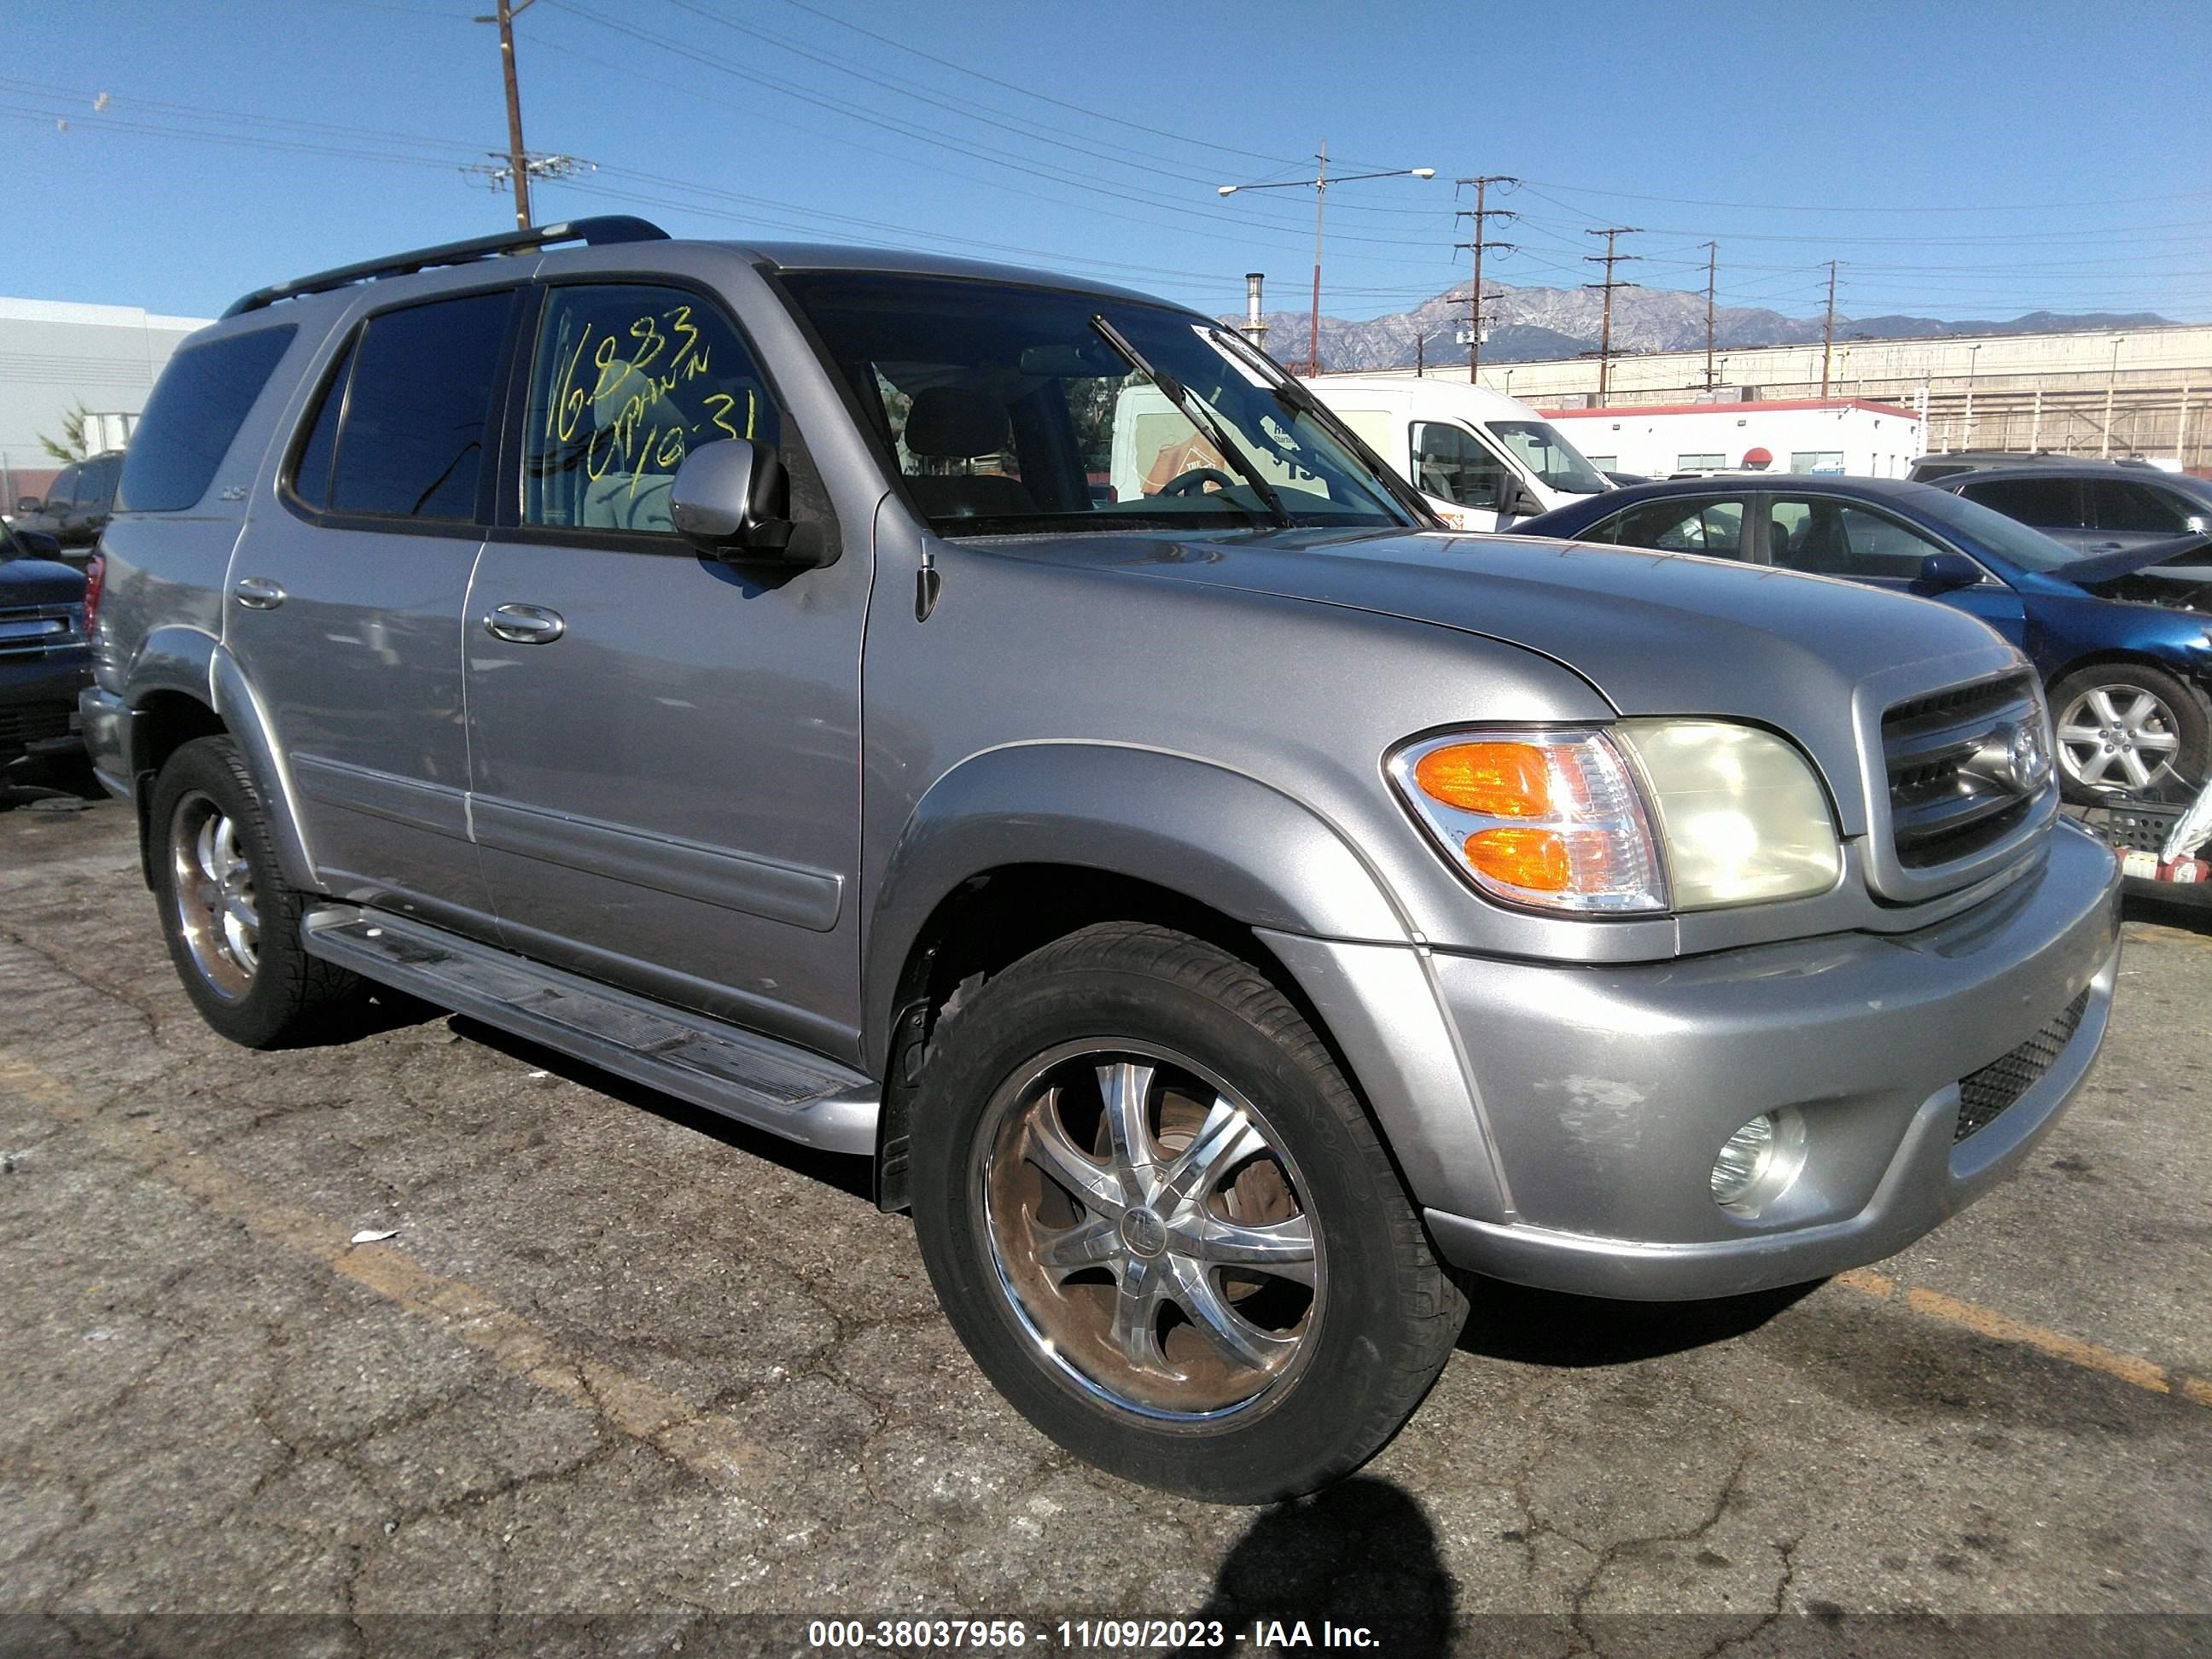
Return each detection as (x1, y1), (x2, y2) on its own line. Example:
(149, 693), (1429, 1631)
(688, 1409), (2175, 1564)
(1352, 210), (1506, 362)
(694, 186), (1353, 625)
(1513, 474), (2212, 800)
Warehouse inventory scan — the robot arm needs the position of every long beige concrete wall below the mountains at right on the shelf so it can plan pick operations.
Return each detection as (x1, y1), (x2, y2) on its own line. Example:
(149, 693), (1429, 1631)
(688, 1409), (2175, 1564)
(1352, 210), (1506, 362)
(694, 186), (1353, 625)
(1415, 323), (2212, 471)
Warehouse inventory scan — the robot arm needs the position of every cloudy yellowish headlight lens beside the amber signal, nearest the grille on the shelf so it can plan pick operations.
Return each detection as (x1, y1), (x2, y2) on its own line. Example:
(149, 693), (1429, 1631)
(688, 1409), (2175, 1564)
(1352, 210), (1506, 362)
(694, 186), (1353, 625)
(1615, 721), (1842, 909)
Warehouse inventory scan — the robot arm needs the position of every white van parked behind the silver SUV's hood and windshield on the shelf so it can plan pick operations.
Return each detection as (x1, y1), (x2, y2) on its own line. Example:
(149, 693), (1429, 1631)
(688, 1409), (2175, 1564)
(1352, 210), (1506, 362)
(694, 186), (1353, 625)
(1305, 374), (1613, 531)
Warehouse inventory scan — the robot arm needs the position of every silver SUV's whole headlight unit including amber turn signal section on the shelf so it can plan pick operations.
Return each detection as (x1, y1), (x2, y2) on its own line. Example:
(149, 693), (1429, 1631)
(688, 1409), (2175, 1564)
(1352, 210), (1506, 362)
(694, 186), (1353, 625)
(1389, 719), (1842, 916)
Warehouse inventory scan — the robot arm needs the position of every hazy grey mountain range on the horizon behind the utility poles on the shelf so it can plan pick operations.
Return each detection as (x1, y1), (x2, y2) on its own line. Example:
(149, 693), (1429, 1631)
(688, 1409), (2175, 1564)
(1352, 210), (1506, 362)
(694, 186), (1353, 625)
(1221, 283), (2170, 370)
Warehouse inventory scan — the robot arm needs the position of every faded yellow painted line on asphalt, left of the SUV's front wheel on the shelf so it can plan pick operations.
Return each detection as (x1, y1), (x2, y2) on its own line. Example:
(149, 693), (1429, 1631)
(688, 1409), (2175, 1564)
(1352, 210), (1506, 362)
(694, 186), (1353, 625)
(0, 1053), (783, 1487)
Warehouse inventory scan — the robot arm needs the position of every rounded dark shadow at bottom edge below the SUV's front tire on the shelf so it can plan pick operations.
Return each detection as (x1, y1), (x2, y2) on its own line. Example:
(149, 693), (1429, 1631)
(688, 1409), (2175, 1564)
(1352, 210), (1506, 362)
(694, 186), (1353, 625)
(1196, 1476), (1460, 1659)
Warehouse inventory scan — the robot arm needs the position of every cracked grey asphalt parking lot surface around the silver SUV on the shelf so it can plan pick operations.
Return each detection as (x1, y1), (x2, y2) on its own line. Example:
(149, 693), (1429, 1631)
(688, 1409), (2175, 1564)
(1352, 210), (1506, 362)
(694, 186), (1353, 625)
(0, 783), (2212, 1655)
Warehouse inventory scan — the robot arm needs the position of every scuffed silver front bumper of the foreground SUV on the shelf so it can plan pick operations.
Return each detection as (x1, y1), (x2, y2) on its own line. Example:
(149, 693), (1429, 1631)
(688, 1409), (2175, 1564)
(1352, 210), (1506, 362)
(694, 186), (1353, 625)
(1318, 823), (2119, 1301)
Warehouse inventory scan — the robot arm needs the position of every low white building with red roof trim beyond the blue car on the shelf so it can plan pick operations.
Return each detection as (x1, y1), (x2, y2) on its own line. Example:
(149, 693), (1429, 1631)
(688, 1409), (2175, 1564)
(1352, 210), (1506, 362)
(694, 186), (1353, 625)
(1542, 399), (1924, 478)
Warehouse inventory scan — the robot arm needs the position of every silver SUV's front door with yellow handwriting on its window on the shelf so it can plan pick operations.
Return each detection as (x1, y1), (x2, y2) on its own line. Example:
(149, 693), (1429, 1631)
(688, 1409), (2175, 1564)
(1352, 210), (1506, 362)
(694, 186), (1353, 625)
(467, 281), (867, 1053)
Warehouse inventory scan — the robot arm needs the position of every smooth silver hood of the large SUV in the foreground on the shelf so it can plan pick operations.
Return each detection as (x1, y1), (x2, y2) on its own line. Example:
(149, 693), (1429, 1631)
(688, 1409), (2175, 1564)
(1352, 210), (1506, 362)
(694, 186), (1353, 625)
(1002, 531), (2022, 834)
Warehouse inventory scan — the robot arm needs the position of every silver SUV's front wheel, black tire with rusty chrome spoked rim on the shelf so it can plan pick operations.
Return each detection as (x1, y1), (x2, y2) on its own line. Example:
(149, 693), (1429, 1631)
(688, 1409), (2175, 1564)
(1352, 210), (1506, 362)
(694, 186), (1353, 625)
(911, 923), (1466, 1505)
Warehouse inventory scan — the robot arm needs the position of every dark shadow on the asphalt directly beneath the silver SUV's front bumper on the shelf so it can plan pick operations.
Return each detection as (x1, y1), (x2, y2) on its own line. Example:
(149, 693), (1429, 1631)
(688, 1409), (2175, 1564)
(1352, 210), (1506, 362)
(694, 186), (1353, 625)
(1460, 1274), (1827, 1369)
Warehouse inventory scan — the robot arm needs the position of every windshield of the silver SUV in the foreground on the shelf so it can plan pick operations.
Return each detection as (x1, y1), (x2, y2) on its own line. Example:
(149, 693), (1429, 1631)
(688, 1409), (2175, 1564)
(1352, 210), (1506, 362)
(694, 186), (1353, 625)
(783, 272), (1420, 535)
